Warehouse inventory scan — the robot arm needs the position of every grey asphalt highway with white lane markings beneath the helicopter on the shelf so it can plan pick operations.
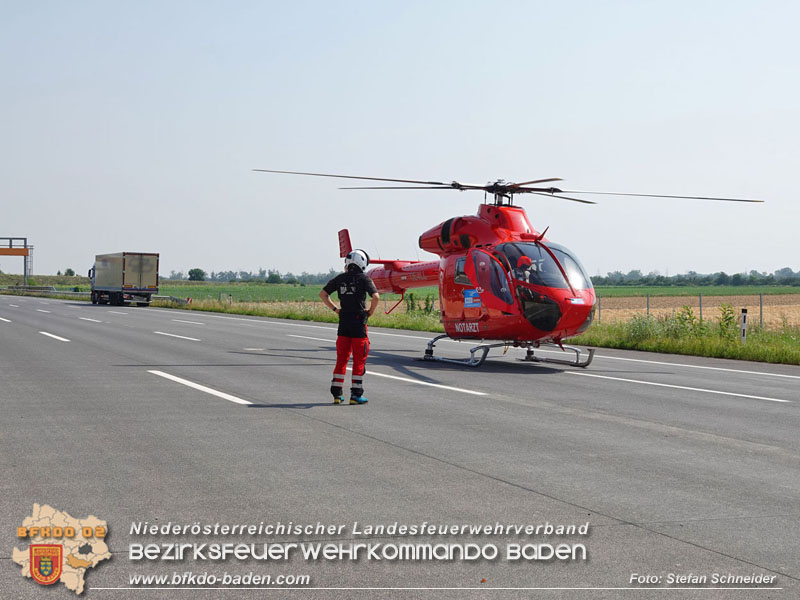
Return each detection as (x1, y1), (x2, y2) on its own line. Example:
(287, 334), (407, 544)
(0, 296), (800, 599)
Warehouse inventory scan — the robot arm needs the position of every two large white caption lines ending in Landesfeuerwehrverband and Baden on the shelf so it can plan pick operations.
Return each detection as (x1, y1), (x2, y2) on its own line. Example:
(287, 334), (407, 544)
(128, 521), (589, 561)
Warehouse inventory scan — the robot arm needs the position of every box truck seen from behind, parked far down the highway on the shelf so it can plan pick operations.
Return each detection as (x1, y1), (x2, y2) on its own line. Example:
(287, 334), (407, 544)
(89, 252), (158, 306)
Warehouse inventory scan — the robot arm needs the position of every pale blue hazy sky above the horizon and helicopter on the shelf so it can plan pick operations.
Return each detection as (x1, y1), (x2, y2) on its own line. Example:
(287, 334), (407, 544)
(0, 0), (800, 274)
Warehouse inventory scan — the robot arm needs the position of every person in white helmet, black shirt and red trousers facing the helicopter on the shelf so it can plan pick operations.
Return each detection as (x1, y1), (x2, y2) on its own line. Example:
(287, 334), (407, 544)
(319, 250), (380, 404)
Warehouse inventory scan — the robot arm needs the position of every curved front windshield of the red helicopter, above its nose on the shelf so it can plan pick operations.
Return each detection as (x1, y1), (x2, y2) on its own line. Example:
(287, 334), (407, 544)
(495, 242), (592, 290)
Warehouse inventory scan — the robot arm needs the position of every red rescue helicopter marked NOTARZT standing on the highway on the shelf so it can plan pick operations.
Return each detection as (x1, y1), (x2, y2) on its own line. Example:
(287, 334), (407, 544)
(254, 169), (763, 367)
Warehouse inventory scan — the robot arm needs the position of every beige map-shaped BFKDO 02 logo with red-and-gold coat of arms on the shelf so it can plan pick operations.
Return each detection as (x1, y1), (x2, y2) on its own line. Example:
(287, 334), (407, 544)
(11, 504), (111, 594)
